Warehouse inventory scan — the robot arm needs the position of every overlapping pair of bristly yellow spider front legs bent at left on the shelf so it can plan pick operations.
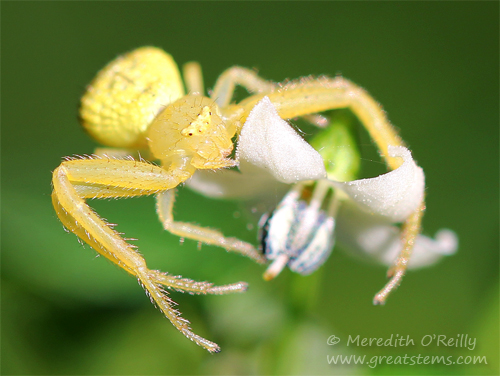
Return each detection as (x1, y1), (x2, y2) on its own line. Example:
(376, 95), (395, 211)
(52, 158), (247, 352)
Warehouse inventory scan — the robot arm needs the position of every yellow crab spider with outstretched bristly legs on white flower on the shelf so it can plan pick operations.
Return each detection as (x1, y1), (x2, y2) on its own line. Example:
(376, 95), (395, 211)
(52, 47), (424, 352)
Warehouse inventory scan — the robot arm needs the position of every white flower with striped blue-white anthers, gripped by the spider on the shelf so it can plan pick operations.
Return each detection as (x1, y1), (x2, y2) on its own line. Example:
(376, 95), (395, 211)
(188, 97), (457, 284)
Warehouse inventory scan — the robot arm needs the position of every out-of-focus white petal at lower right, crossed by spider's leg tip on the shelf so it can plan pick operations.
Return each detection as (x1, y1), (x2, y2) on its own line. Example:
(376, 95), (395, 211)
(336, 203), (458, 269)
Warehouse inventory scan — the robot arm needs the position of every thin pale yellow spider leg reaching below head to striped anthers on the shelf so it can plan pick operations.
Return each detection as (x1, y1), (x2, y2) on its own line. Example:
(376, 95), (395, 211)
(156, 189), (266, 263)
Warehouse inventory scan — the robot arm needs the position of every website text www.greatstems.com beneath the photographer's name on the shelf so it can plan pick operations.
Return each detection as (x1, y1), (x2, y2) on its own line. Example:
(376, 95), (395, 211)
(326, 354), (488, 368)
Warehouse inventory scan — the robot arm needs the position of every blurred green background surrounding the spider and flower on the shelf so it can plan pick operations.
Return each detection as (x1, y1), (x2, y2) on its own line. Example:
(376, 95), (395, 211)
(1, 2), (499, 375)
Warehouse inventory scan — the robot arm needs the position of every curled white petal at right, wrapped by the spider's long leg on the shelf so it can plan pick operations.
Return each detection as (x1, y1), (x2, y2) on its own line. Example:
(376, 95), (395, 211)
(333, 146), (425, 222)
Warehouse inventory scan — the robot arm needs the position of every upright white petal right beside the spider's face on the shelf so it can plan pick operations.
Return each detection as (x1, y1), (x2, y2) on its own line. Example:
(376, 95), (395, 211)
(236, 97), (326, 183)
